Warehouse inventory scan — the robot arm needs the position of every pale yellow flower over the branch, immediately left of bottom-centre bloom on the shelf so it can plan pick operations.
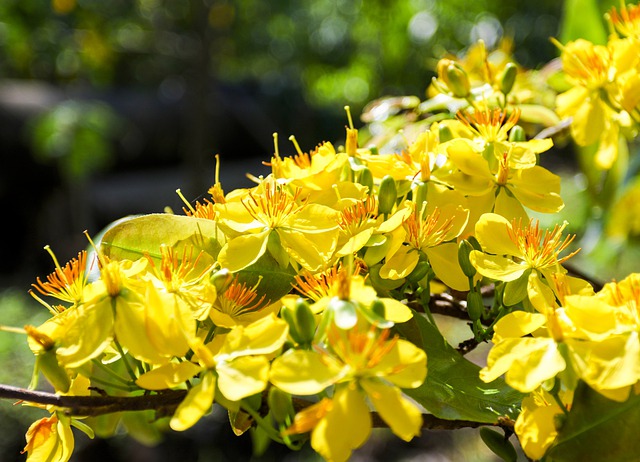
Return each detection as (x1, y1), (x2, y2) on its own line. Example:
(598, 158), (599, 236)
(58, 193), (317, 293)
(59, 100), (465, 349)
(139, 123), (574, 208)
(136, 314), (288, 431)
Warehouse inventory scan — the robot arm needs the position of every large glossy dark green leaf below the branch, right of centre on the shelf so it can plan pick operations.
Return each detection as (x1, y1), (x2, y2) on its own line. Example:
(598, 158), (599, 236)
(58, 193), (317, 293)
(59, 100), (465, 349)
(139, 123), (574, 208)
(397, 313), (523, 423)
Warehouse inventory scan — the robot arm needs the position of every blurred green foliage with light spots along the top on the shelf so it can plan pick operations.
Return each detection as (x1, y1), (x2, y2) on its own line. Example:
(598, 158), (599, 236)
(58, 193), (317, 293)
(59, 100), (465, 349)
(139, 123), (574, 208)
(0, 0), (610, 109)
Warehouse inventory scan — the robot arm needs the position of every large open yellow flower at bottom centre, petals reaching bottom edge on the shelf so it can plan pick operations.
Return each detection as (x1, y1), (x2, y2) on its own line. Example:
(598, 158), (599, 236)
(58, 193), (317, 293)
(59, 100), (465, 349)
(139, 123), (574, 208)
(270, 324), (427, 461)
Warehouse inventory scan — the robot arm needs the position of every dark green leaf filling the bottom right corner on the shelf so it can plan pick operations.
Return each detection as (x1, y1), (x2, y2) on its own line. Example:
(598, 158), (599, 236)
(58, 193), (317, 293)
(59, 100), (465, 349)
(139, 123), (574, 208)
(547, 383), (640, 462)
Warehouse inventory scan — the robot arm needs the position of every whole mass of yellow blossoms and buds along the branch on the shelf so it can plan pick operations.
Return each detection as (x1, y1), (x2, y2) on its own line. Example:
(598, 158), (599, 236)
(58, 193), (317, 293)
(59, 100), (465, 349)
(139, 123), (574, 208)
(8, 1), (640, 461)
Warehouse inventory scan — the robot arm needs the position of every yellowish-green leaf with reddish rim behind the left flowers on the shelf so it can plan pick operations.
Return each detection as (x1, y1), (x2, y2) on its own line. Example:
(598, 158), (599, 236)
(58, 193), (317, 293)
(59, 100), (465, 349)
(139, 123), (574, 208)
(100, 213), (223, 266)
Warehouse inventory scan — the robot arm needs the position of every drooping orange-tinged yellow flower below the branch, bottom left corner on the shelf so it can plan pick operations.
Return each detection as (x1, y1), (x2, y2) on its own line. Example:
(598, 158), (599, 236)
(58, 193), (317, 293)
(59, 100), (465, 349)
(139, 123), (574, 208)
(22, 412), (74, 462)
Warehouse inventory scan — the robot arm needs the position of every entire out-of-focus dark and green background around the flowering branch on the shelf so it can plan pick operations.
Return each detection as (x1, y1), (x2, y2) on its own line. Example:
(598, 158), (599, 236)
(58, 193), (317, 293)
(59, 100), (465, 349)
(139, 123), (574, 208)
(0, 0), (617, 461)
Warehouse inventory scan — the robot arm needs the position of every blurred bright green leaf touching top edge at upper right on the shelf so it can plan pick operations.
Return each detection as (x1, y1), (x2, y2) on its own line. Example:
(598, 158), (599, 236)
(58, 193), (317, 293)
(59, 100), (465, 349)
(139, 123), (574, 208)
(560, 0), (607, 45)
